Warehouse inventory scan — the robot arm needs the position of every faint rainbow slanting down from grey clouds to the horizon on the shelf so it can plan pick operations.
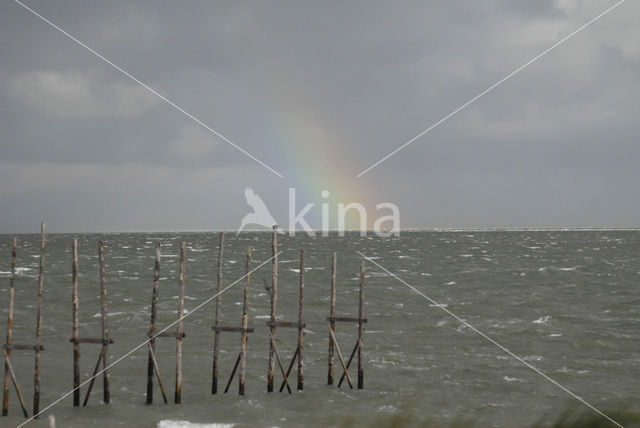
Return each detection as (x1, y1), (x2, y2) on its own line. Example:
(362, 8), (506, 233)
(244, 55), (379, 229)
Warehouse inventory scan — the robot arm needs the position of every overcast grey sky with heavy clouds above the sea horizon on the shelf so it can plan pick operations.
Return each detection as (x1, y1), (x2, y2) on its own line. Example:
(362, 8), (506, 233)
(0, 0), (640, 233)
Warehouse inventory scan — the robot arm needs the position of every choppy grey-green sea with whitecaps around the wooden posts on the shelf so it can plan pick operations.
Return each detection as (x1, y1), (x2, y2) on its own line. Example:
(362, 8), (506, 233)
(0, 230), (640, 428)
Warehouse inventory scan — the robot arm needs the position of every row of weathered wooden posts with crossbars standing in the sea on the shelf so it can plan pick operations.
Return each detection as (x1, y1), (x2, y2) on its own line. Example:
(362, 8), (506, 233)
(2, 226), (367, 417)
